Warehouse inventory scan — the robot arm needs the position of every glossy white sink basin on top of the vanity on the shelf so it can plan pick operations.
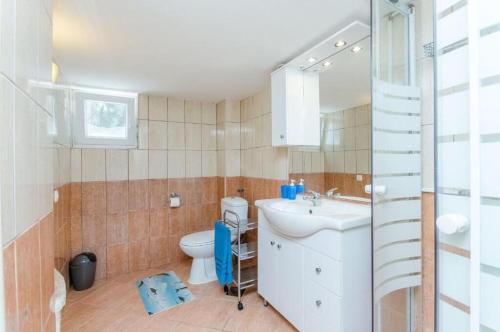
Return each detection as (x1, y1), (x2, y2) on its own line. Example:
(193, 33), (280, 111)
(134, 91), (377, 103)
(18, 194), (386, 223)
(255, 196), (371, 237)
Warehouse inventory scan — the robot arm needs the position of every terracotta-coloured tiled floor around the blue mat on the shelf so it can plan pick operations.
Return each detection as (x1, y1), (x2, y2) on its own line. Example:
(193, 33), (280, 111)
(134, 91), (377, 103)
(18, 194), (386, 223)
(62, 261), (295, 332)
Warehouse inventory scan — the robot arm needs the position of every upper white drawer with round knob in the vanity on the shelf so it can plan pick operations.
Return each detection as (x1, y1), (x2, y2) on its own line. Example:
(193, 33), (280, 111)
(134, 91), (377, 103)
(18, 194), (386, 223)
(304, 249), (342, 296)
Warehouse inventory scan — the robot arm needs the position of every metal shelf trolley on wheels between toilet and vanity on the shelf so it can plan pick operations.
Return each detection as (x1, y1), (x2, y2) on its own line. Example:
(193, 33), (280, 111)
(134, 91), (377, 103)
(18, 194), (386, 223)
(222, 210), (258, 310)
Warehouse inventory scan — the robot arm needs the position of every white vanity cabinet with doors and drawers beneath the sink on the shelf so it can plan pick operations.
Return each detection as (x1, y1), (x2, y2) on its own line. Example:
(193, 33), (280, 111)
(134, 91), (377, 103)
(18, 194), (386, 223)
(258, 210), (371, 332)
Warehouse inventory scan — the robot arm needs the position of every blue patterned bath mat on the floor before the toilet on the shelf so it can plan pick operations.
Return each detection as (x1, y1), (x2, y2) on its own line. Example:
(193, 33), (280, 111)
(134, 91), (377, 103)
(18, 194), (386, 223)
(136, 271), (194, 315)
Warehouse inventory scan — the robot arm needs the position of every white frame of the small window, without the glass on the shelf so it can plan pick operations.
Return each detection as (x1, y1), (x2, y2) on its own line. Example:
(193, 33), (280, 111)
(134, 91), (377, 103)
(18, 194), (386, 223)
(71, 88), (139, 149)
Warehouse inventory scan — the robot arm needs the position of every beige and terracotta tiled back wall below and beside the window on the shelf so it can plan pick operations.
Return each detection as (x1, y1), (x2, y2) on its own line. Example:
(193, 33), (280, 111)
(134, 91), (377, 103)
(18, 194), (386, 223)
(71, 95), (219, 278)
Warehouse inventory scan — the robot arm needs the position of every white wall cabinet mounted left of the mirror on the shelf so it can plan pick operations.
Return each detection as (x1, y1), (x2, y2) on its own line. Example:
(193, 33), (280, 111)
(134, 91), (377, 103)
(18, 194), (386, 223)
(271, 67), (320, 146)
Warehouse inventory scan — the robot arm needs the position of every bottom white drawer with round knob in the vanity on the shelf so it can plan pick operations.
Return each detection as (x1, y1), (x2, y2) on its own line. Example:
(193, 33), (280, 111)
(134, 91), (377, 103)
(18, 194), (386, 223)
(304, 280), (342, 332)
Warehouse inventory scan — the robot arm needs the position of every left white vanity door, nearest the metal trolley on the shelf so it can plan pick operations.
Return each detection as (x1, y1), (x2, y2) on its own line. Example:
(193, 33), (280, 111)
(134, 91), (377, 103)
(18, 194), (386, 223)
(258, 227), (278, 306)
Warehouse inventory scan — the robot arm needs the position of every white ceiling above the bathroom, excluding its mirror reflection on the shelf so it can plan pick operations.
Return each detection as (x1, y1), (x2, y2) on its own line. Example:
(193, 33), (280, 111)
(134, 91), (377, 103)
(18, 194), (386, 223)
(54, 0), (369, 101)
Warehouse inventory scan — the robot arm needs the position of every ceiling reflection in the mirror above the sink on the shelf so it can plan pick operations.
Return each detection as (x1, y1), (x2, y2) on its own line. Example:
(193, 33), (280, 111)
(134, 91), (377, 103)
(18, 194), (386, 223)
(319, 38), (371, 113)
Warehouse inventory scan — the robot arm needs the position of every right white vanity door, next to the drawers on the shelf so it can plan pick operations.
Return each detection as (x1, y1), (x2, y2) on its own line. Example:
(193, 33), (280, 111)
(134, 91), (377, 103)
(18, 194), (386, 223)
(276, 237), (304, 330)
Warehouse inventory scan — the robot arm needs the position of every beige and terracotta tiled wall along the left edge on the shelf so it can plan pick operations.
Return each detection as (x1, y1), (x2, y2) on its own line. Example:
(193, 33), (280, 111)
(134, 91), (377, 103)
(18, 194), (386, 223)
(0, 0), (64, 331)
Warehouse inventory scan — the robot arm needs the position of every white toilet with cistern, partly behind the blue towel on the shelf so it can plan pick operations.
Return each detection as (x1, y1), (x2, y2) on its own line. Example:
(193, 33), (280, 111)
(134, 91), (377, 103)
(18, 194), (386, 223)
(179, 197), (248, 284)
